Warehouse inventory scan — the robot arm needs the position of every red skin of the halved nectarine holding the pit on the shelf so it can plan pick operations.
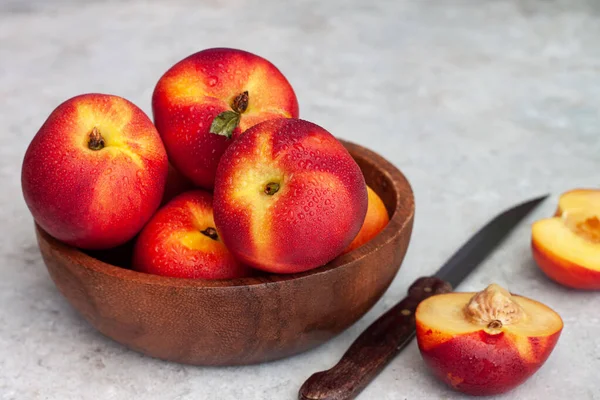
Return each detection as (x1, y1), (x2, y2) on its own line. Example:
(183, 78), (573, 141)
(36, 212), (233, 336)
(417, 324), (561, 396)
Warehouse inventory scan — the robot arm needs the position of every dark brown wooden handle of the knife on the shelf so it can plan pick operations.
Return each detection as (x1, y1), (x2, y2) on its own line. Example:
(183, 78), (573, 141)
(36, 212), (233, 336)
(298, 277), (452, 400)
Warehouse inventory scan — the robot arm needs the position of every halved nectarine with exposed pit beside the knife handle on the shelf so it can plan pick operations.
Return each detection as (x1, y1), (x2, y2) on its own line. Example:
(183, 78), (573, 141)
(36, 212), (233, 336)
(415, 284), (563, 395)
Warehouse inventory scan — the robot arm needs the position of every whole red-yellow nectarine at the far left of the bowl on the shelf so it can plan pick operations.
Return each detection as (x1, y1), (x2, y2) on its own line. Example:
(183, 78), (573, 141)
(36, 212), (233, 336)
(21, 93), (168, 249)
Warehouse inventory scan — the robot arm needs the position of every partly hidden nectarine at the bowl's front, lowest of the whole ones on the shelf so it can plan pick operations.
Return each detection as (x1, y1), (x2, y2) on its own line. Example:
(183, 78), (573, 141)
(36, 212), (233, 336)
(133, 190), (253, 279)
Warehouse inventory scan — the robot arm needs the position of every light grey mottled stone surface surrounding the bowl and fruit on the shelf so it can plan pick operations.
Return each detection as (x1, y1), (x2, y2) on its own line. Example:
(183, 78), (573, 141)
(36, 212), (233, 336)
(0, 0), (600, 400)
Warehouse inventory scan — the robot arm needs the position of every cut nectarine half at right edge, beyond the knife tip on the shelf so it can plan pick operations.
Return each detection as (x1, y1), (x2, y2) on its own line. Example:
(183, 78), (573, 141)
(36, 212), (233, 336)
(531, 189), (600, 289)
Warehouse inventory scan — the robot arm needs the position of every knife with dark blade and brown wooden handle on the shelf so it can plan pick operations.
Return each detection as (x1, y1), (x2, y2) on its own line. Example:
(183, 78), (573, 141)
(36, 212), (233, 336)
(298, 195), (548, 400)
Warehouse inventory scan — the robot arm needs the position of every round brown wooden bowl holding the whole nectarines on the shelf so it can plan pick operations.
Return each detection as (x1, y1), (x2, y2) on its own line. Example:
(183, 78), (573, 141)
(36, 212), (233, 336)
(36, 142), (414, 365)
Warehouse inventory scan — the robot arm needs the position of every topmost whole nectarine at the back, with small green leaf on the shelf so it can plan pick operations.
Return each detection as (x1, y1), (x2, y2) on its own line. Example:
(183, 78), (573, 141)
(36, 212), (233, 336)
(152, 48), (299, 190)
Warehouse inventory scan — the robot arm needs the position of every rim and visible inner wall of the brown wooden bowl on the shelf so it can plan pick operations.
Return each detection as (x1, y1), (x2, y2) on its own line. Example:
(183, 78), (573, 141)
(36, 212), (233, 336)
(47, 140), (414, 287)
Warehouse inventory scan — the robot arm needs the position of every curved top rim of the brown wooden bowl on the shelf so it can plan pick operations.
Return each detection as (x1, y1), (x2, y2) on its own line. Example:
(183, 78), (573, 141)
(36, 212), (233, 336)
(35, 139), (415, 288)
